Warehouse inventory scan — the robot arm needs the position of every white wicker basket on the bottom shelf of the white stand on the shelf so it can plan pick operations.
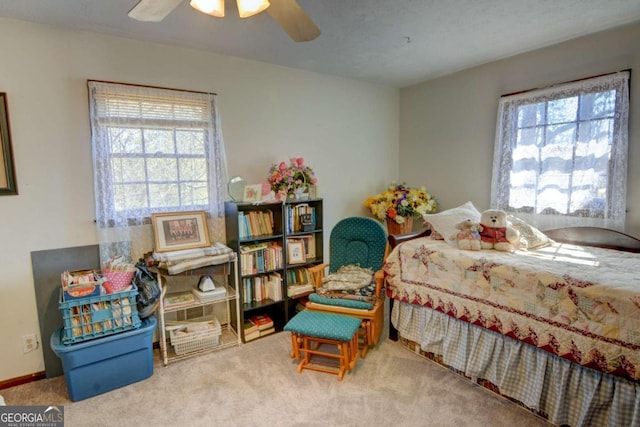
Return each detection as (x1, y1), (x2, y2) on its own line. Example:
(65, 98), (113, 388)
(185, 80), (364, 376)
(169, 317), (222, 355)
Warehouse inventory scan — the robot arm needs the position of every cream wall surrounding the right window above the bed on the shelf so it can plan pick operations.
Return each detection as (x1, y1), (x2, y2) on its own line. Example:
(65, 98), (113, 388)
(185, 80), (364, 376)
(400, 23), (640, 237)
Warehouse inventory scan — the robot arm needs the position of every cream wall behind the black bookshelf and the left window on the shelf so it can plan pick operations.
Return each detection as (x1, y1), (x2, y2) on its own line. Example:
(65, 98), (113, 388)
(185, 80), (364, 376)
(0, 19), (399, 381)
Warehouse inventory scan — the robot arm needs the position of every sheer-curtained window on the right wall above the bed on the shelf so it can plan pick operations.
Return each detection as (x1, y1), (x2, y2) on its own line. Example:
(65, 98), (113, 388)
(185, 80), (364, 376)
(491, 72), (629, 229)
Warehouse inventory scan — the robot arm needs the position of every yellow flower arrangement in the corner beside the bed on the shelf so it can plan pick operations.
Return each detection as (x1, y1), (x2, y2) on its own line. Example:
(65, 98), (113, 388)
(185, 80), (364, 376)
(364, 182), (438, 224)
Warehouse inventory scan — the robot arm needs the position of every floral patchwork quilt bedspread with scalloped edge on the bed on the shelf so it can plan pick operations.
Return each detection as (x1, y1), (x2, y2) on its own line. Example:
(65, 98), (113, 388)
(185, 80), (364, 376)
(384, 238), (640, 380)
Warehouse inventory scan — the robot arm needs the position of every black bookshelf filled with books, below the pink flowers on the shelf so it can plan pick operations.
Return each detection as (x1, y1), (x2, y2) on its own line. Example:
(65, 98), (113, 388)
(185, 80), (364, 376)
(225, 199), (324, 342)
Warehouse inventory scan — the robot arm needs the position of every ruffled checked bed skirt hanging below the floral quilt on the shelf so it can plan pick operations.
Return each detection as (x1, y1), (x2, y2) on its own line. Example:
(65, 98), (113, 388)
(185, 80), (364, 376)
(391, 301), (640, 427)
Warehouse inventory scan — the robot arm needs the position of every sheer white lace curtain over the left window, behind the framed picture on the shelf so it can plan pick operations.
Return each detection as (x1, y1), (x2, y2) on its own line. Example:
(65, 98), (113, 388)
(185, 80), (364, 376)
(88, 81), (228, 264)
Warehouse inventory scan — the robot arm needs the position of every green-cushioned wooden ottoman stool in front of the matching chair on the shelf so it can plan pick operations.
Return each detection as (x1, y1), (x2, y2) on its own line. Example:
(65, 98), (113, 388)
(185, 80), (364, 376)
(284, 310), (362, 381)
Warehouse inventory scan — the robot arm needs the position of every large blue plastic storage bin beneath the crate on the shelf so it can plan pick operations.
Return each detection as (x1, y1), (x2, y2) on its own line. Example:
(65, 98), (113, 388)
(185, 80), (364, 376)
(50, 317), (157, 402)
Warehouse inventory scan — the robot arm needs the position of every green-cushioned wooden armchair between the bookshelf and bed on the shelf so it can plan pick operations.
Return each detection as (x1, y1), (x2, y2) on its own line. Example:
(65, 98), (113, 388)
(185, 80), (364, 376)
(306, 217), (387, 357)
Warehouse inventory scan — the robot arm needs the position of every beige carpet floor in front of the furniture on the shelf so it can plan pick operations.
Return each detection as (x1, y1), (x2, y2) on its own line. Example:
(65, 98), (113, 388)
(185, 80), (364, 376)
(0, 332), (550, 427)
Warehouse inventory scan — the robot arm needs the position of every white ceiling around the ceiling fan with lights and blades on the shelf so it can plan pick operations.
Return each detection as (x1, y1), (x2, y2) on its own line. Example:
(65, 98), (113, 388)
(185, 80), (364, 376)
(0, 0), (640, 87)
